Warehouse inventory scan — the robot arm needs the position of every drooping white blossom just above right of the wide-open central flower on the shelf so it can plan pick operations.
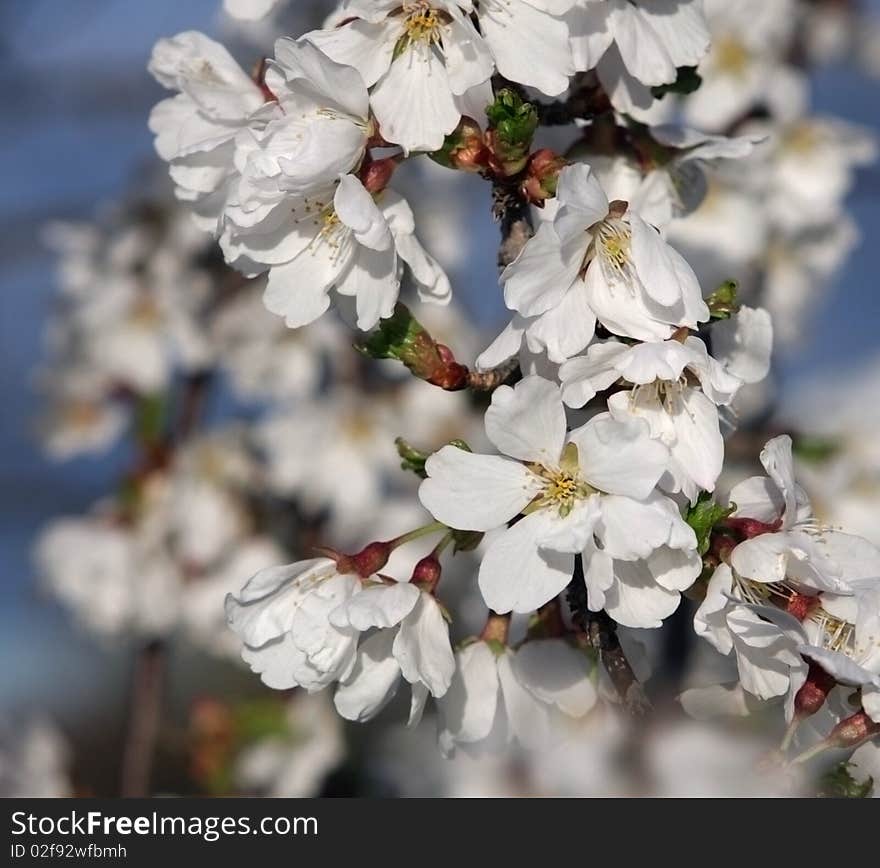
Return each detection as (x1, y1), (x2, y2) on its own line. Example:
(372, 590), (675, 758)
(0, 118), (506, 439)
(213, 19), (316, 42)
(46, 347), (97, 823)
(559, 308), (772, 502)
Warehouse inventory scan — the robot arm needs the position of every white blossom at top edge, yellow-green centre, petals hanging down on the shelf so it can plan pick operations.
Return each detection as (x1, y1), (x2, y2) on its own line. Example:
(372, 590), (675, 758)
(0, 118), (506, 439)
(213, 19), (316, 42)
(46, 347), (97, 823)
(305, 0), (494, 151)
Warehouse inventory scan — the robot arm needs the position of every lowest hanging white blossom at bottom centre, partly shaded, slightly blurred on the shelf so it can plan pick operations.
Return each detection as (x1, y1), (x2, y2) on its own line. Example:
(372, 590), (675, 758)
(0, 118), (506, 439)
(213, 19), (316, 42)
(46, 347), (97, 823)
(438, 639), (597, 756)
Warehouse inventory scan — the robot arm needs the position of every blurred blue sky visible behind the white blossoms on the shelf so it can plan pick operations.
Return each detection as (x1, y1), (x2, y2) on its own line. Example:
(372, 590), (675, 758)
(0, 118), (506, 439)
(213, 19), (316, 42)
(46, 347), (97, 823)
(0, 0), (880, 713)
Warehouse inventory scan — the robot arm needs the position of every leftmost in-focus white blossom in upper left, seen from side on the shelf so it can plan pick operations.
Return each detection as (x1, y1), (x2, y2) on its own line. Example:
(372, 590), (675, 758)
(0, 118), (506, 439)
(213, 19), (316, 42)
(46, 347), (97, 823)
(149, 30), (265, 231)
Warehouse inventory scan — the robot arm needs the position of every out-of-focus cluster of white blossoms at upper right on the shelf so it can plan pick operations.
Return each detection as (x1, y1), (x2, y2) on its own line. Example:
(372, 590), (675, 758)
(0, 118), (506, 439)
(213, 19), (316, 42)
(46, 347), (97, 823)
(670, 0), (877, 345)
